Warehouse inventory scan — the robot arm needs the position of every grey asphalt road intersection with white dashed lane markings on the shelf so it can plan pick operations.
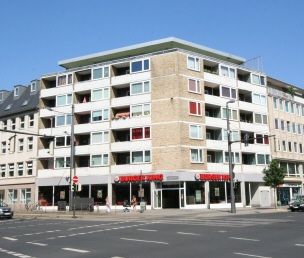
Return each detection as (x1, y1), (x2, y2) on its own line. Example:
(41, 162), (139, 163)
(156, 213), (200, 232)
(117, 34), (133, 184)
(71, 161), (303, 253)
(0, 212), (304, 258)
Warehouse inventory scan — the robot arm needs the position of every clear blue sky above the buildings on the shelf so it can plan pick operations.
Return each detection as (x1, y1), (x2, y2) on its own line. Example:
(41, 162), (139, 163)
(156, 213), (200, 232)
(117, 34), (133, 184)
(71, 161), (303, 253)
(0, 0), (304, 89)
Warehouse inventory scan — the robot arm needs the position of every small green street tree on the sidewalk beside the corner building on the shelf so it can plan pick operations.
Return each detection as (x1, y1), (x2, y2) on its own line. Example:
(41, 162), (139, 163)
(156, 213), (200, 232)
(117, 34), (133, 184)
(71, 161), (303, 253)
(263, 160), (286, 208)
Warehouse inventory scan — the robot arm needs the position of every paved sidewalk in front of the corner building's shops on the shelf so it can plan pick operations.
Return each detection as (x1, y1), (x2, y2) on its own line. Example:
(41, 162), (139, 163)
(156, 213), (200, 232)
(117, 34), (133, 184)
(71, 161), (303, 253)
(14, 207), (288, 220)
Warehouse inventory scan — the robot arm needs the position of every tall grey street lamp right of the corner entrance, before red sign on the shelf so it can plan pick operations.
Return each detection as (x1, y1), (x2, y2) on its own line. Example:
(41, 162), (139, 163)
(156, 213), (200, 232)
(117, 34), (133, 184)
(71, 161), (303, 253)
(226, 99), (236, 213)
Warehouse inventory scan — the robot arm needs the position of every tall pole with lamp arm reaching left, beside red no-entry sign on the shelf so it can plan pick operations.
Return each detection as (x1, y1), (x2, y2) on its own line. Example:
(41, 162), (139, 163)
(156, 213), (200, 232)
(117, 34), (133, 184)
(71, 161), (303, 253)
(46, 103), (76, 218)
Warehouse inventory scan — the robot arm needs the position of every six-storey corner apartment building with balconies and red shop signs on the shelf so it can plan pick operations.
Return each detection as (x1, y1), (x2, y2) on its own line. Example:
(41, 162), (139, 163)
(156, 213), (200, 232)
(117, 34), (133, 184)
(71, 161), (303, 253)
(36, 38), (271, 209)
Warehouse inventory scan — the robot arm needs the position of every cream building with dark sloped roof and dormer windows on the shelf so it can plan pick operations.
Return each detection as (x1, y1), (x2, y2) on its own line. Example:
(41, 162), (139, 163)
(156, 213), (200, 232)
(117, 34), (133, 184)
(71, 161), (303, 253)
(0, 80), (40, 209)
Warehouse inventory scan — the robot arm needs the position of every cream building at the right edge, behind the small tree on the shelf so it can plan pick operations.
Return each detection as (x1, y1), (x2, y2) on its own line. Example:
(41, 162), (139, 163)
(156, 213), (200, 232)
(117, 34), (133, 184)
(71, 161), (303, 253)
(268, 77), (304, 205)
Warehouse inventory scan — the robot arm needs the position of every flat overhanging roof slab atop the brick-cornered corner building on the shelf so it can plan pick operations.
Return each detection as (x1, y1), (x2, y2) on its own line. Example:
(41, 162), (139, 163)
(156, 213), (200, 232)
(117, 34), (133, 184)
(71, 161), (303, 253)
(58, 37), (246, 69)
